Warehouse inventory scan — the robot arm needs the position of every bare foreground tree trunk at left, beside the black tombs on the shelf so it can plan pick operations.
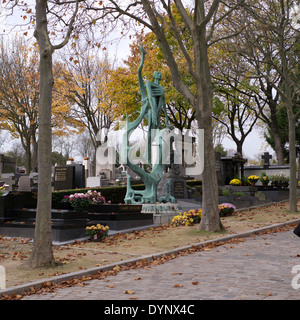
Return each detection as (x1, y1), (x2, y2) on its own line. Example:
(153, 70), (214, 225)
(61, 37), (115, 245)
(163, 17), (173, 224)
(28, 0), (54, 268)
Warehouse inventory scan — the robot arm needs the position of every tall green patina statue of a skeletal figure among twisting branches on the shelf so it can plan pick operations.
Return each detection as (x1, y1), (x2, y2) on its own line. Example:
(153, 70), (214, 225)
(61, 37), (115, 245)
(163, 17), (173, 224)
(121, 44), (175, 204)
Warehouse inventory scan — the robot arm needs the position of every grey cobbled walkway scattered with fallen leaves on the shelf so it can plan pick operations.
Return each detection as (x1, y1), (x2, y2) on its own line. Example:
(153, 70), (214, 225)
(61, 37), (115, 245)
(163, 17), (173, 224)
(23, 231), (300, 300)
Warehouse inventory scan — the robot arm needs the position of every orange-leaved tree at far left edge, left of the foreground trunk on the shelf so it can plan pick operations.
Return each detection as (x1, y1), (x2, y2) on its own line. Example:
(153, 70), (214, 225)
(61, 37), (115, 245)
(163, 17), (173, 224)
(0, 38), (39, 173)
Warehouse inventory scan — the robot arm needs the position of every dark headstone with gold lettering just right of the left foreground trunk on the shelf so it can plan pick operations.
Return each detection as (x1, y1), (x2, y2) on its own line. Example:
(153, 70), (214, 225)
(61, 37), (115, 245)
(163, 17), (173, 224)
(53, 166), (75, 190)
